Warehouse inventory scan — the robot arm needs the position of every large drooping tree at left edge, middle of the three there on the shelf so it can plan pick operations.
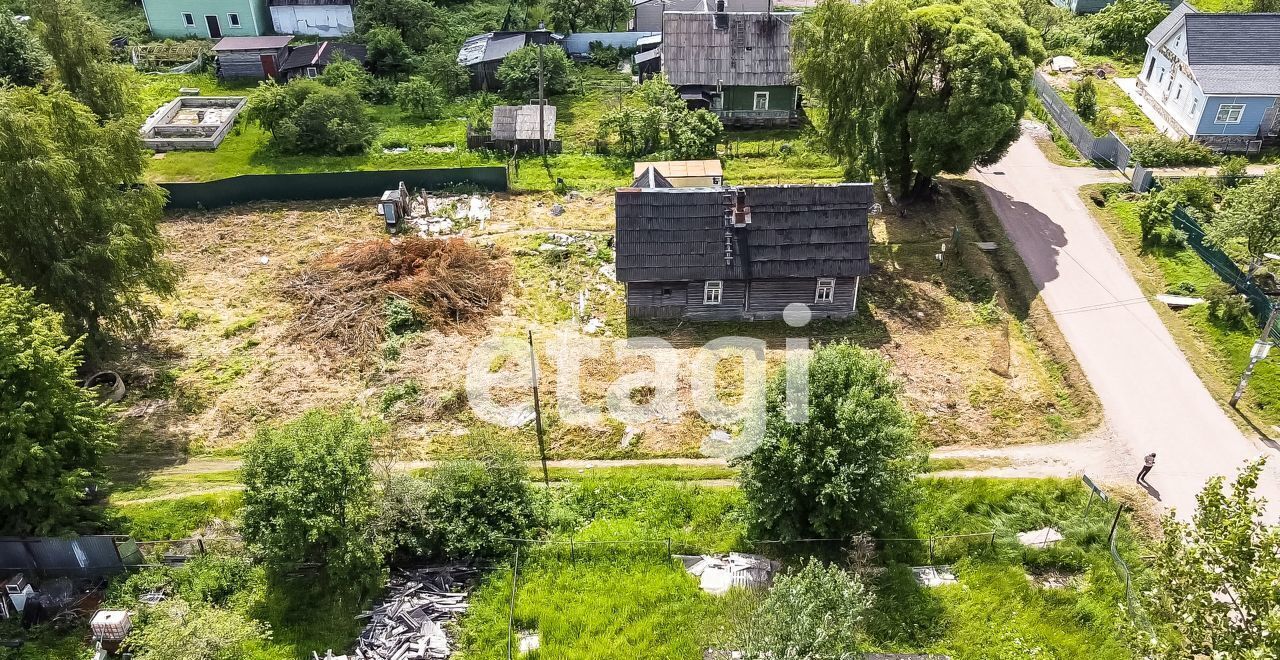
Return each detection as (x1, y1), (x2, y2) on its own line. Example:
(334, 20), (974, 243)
(0, 87), (175, 352)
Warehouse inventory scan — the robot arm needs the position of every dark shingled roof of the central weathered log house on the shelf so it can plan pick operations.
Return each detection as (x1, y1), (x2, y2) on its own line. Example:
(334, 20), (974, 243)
(614, 183), (873, 281)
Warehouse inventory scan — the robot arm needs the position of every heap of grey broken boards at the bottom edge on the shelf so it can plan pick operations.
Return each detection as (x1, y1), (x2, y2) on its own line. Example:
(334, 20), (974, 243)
(314, 567), (477, 660)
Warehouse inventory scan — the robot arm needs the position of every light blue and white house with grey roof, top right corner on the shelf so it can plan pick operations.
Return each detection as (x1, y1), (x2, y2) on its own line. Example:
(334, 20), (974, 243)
(1137, 3), (1280, 151)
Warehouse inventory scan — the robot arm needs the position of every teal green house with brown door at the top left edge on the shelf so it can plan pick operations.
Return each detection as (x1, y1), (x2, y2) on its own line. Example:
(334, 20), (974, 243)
(142, 0), (271, 40)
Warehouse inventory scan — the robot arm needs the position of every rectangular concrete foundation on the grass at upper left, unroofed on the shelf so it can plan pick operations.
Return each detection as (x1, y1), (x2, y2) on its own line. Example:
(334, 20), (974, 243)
(141, 96), (246, 151)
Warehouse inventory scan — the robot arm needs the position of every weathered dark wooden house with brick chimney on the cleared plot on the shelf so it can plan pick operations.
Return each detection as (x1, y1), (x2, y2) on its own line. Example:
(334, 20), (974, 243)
(614, 179), (873, 321)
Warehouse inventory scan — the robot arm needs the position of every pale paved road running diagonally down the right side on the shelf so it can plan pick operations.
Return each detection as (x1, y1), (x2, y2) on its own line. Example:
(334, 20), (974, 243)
(972, 136), (1280, 518)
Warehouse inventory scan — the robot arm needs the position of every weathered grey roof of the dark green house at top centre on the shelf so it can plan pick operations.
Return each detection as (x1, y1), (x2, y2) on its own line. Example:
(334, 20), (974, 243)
(662, 12), (799, 87)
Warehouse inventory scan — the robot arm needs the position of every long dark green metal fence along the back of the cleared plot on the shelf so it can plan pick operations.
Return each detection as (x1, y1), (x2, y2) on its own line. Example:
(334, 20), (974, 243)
(160, 165), (507, 208)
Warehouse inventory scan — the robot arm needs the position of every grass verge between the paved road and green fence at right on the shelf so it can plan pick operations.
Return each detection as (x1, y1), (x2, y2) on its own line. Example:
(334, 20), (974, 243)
(1082, 187), (1280, 426)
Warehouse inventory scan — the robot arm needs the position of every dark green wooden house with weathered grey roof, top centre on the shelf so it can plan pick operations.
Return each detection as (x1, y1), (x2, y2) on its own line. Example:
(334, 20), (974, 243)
(662, 12), (800, 124)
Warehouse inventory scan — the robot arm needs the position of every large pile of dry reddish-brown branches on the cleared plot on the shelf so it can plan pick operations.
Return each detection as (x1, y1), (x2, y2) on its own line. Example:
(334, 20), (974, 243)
(284, 237), (511, 350)
